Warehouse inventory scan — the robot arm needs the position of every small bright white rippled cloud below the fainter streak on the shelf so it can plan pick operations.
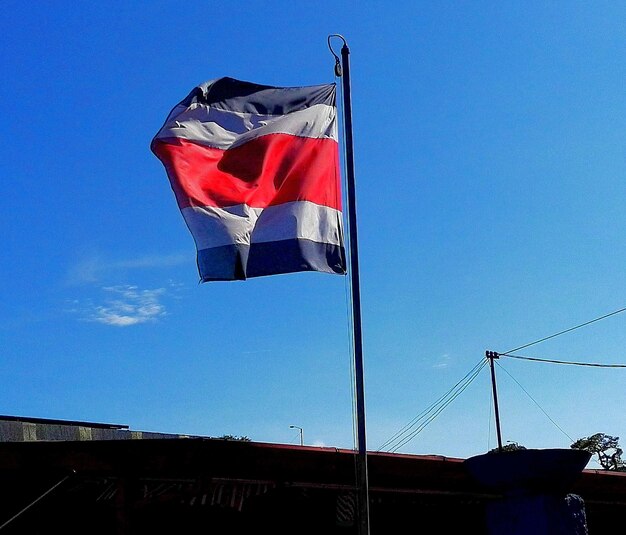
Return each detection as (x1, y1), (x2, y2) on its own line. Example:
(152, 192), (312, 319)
(86, 285), (167, 327)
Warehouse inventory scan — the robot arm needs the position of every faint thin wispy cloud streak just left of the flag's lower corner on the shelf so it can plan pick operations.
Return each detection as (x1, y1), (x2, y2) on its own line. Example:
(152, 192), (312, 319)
(66, 253), (190, 285)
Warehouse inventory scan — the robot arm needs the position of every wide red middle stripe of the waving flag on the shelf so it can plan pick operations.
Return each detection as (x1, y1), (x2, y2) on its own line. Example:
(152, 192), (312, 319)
(152, 134), (341, 210)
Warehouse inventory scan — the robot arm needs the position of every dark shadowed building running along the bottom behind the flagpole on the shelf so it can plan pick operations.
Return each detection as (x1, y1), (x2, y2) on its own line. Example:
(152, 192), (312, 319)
(0, 416), (626, 535)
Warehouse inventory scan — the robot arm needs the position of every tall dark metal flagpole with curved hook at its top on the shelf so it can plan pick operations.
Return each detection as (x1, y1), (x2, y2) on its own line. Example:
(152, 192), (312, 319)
(328, 34), (370, 535)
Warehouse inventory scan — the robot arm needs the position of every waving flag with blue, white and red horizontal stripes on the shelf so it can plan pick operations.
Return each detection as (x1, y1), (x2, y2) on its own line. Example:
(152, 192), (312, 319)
(151, 78), (346, 282)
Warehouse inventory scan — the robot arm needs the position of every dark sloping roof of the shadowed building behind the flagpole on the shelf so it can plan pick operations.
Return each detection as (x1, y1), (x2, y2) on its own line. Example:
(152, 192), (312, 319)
(0, 438), (626, 505)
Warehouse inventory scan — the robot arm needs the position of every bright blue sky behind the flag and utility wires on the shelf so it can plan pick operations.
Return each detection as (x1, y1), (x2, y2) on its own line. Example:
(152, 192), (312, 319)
(0, 1), (626, 457)
